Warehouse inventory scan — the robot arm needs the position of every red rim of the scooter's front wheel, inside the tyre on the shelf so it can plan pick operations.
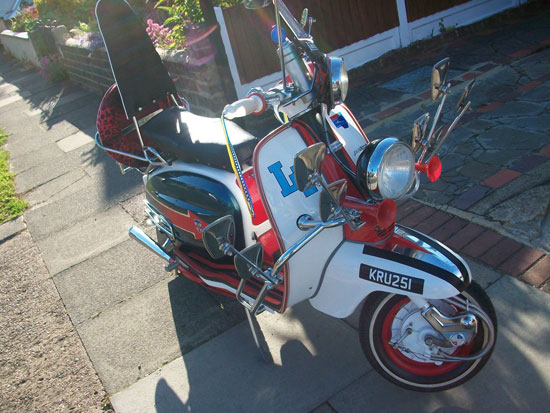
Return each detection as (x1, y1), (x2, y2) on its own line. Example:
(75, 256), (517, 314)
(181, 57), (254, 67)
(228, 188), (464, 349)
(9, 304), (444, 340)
(382, 297), (473, 377)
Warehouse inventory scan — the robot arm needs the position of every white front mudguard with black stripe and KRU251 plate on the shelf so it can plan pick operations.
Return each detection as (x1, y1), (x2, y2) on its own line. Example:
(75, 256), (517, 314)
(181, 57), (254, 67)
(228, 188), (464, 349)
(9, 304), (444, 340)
(310, 225), (472, 318)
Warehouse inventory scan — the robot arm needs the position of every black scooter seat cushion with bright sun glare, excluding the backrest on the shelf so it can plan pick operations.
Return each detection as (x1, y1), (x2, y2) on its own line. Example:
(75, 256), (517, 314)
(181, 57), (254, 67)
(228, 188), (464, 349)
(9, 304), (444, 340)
(141, 106), (258, 171)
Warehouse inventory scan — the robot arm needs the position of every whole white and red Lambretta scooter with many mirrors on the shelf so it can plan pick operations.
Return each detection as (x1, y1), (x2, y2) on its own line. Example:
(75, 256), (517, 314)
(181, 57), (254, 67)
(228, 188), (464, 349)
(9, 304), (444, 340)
(96, 0), (497, 391)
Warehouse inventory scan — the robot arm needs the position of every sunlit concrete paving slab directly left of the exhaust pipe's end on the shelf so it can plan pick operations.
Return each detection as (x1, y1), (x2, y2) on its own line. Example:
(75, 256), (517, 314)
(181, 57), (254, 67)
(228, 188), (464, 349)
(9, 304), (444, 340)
(37, 206), (134, 275)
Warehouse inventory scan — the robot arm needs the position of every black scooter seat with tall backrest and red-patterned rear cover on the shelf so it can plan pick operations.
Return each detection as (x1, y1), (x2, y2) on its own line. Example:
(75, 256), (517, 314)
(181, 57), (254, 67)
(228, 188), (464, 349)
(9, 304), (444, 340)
(96, 0), (258, 170)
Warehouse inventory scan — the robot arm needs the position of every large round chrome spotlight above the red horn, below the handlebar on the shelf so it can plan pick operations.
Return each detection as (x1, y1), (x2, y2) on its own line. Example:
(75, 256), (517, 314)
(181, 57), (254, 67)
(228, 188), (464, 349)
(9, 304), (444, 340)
(357, 138), (415, 200)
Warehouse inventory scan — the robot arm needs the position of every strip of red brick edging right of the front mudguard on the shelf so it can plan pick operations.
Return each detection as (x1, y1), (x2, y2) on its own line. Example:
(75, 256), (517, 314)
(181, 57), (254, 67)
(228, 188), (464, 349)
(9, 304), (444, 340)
(397, 200), (550, 293)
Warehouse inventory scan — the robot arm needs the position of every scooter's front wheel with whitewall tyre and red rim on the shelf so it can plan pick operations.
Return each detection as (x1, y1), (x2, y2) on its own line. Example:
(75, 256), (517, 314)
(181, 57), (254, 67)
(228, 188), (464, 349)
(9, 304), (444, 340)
(359, 283), (497, 392)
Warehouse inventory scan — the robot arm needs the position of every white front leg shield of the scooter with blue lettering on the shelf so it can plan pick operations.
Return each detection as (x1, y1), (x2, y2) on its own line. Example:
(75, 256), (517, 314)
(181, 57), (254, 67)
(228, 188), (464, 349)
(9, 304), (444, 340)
(254, 128), (343, 306)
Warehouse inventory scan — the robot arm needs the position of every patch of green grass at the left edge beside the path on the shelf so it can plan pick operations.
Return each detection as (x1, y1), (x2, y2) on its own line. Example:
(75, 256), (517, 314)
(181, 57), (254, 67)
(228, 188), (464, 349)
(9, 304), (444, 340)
(0, 129), (27, 224)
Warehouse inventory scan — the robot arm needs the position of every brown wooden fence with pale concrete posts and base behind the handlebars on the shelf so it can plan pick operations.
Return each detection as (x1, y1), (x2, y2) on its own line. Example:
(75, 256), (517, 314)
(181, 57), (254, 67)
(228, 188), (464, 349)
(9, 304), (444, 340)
(215, 0), (526, 97)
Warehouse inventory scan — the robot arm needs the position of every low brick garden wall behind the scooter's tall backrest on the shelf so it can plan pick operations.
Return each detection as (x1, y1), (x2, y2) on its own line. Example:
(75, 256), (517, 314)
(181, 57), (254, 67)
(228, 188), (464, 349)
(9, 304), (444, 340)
(59, 39), (227, 116)
